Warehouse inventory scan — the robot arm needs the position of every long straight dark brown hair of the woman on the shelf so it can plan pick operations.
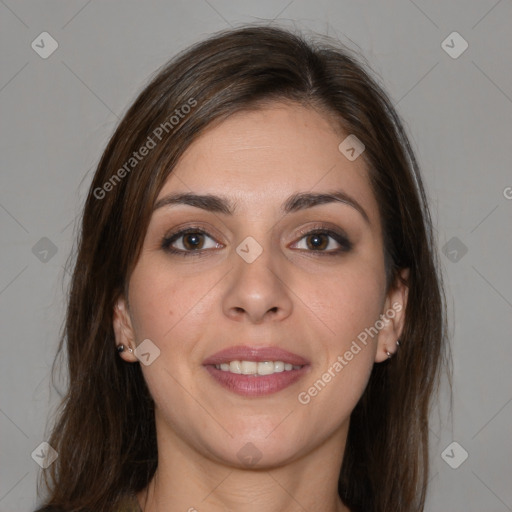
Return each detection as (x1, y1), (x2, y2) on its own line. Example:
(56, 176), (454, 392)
(36, 25), (449, 512)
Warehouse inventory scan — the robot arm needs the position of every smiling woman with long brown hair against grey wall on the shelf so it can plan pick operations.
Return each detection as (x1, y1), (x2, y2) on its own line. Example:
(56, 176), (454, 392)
(35, 26), (446, 512)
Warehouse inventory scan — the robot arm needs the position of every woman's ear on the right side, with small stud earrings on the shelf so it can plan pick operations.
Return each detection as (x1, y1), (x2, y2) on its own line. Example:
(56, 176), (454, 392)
(375, 268), (409, 363)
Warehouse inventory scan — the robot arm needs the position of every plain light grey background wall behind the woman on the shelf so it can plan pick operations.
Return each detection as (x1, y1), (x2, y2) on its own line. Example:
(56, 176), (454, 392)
(0, 0), (512, 512)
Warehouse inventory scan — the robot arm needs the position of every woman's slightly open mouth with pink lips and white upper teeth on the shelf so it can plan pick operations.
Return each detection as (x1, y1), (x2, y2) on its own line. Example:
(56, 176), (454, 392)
(203, 346), (310, 396)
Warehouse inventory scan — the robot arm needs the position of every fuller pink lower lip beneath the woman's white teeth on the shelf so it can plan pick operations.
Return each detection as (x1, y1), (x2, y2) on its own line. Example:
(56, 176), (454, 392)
(205, 365), (309, 396)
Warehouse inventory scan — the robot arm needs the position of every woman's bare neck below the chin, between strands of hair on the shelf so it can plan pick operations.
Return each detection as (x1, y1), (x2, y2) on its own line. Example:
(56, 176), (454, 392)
(137, 416), (350, 512)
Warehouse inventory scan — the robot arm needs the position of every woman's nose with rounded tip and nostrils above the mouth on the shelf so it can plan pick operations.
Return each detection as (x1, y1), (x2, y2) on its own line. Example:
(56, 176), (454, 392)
(223, 240), (293, 324)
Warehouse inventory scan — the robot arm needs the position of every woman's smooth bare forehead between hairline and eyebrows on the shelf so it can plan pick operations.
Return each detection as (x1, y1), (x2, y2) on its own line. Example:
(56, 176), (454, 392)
(158, 103), (377, 222)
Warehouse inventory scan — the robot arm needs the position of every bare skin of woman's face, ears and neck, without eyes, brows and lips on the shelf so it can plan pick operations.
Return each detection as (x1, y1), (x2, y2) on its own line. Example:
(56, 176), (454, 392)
(114, 103), (407, 512)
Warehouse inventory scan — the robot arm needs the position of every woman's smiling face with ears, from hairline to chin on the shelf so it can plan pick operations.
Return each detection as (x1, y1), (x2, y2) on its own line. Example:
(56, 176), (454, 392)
(114, 103), (406, 466)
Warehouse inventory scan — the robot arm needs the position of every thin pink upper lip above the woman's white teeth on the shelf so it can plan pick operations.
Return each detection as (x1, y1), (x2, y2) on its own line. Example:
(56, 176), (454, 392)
(203, 345), (309, 366)
